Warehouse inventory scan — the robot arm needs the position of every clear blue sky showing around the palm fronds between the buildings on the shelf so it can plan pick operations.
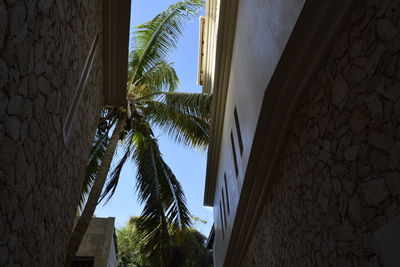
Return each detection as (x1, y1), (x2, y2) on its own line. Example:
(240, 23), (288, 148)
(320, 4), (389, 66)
(95, 0), (212, 236)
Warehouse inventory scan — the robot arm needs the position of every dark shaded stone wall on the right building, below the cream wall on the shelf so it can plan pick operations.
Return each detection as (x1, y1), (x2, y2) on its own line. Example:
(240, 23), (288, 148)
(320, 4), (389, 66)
(242, 0), (400, 266)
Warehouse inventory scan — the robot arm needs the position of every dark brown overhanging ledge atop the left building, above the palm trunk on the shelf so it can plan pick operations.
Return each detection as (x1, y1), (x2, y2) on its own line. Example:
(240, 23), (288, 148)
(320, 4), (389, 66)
(103, 0), (131, 107)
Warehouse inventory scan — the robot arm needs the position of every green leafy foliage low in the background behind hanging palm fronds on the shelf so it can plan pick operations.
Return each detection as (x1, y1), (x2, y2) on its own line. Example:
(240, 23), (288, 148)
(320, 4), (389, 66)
(117, 217), (212, 267)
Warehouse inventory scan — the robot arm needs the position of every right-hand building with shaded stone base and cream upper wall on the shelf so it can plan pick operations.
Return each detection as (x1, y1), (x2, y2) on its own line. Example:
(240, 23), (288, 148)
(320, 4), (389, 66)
(200, 0), (400, 266)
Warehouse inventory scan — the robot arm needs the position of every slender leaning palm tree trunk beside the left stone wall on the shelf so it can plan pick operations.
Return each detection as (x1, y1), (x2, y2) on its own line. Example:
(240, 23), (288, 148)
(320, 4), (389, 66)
(65, 113), (126, 267)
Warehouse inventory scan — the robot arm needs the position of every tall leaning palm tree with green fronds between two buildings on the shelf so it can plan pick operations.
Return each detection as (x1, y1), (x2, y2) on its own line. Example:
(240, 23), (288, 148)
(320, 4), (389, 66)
(65, 0), (211, 266)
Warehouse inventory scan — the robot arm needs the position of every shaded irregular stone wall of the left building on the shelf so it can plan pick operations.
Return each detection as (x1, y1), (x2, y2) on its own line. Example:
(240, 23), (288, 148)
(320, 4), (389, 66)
(0, 0), (103, 266)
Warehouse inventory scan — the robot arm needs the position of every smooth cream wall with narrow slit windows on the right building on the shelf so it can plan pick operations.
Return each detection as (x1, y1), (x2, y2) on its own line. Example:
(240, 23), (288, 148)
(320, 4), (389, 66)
(214, 0), (304, 266)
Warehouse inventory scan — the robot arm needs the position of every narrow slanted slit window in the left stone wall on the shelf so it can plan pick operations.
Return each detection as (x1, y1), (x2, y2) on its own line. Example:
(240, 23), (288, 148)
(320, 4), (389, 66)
(63, 34), (99, 142)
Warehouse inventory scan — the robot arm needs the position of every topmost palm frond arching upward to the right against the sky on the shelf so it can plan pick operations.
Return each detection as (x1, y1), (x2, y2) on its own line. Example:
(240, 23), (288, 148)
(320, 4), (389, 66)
(128, 0), (204, 88)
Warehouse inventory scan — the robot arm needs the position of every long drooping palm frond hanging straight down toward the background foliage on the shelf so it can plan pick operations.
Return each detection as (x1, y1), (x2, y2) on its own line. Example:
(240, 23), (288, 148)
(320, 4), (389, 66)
(133, 128), (190, 266)
